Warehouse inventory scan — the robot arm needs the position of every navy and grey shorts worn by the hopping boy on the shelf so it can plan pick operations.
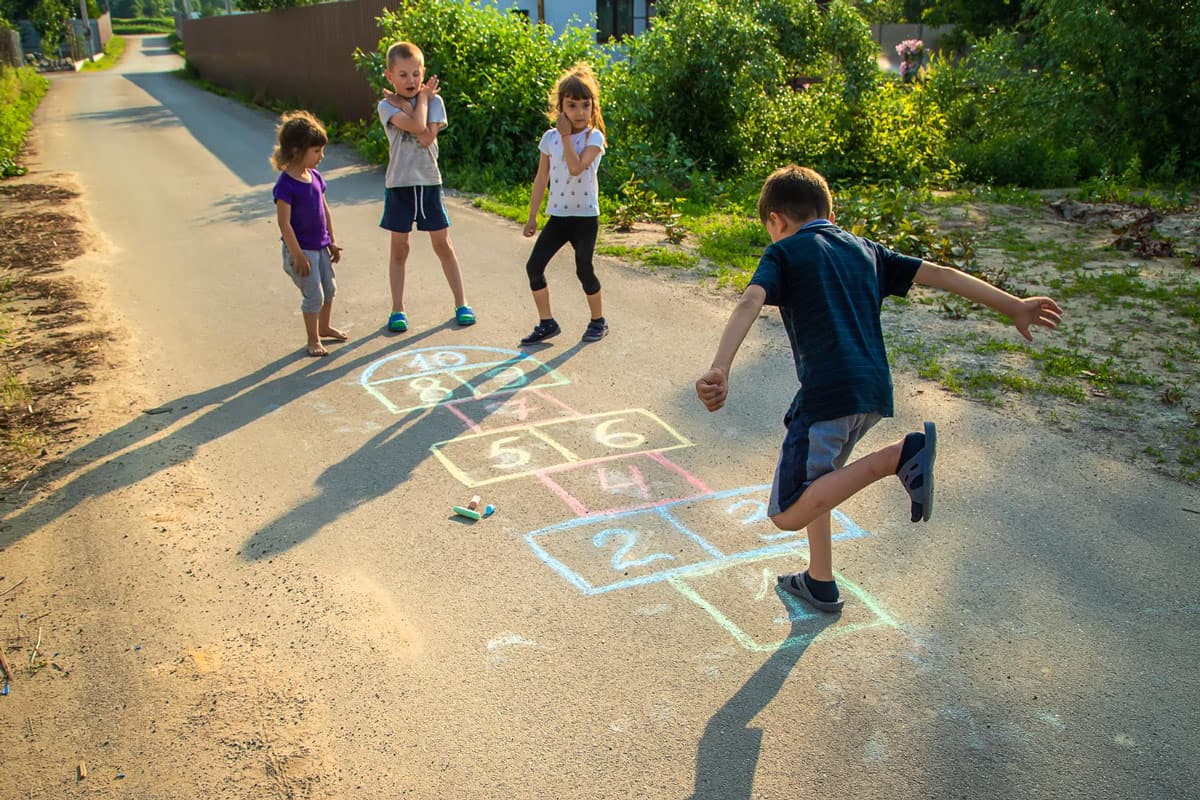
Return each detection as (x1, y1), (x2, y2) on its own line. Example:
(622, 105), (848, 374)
(767, 414), (883, 517)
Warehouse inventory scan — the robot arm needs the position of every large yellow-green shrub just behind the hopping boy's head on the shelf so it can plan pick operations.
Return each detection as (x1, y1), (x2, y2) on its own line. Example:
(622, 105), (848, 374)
(610, 0), (878, 181)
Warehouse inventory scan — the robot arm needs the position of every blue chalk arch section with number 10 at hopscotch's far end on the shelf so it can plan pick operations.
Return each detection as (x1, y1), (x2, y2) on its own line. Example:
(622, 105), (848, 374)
(359, 344), (570, 414)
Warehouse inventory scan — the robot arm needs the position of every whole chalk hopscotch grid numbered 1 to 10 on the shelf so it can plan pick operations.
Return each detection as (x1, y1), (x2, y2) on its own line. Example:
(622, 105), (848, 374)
(360, 345), (898, 651)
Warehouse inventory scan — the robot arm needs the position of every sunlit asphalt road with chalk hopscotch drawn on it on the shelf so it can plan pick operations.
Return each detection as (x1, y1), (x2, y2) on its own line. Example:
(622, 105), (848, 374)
(0, 37), (1200, 800)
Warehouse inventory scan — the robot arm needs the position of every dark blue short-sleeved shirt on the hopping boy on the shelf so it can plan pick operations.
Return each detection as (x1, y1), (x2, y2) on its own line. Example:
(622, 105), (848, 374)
(750, 219), (922, 425)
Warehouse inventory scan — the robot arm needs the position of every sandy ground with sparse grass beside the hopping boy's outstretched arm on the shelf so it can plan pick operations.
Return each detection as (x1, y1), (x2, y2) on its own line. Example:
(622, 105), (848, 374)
(887, 198), (1200, 486)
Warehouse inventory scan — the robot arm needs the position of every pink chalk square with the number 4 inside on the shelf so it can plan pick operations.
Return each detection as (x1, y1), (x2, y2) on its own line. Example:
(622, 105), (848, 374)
(538, 453), (709, 517)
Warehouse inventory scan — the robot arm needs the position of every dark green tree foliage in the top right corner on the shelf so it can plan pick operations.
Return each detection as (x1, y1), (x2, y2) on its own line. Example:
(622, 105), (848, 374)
(930, 0), (1200, 186)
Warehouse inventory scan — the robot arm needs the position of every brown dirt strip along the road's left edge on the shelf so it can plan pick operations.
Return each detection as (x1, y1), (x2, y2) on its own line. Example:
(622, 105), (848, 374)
(0, 176), (106, 497)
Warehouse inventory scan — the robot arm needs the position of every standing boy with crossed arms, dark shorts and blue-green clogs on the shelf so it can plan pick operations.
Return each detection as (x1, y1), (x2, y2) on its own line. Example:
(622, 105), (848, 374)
(377, 42), (475, 333)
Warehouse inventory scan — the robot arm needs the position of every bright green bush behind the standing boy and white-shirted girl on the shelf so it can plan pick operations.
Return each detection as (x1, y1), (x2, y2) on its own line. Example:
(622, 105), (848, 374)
(355, 0), (607, 181)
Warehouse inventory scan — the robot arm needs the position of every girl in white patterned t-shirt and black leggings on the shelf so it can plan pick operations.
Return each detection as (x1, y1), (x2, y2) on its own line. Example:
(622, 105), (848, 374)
(521, 64), (608, 344)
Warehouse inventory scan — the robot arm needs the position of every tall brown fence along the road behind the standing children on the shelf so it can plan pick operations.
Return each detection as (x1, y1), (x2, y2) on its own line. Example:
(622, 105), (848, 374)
(180, 0), (398, 120)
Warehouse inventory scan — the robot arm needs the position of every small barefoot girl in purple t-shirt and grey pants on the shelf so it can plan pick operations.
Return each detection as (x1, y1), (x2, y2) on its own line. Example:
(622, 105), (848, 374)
(271, 112), (346, 356)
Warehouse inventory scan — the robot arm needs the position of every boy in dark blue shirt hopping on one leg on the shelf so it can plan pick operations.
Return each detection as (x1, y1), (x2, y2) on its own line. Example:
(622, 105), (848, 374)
(696, 164), (1062, 612)
